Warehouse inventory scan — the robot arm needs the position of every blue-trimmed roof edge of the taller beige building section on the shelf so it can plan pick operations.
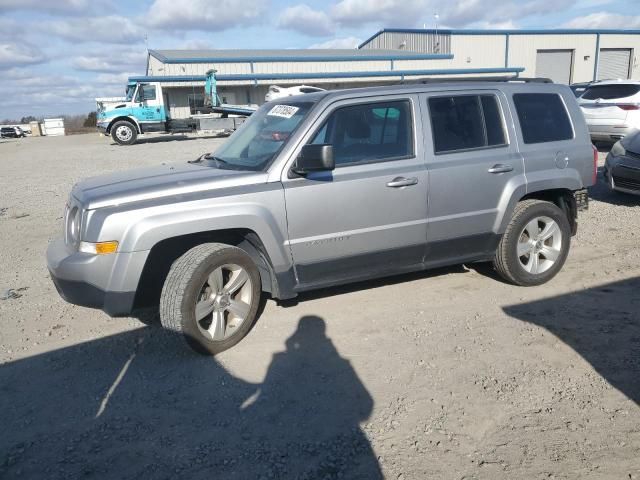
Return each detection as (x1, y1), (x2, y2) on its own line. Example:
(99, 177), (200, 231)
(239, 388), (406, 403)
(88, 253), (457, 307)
(358, 28), (640, 49)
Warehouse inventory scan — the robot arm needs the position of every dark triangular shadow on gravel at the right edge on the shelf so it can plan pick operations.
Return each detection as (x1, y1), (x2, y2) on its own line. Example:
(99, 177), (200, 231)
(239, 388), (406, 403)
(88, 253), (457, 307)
(504, 277), (640, 405)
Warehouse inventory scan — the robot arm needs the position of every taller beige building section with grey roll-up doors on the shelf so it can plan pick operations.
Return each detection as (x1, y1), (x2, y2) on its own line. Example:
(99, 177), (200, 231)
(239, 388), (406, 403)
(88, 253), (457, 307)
(358, 29), (640, 84)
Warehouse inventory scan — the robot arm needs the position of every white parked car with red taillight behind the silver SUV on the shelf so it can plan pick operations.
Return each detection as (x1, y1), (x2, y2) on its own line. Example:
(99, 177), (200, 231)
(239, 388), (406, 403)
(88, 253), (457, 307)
(578, 80), (640, 142)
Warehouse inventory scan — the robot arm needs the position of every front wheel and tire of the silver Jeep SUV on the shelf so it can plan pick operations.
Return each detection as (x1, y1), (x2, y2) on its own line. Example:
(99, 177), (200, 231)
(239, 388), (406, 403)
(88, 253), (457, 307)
(160, 243), (262, 355)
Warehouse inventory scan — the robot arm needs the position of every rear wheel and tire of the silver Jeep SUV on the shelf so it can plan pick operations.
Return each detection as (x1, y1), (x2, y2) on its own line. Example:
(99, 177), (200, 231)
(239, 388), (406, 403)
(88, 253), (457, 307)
(493, 200), (571, 287)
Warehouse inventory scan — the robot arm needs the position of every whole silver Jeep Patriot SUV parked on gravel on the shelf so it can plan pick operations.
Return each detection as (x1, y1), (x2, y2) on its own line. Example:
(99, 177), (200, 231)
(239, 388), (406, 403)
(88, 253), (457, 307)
(47, 82), (597, 354)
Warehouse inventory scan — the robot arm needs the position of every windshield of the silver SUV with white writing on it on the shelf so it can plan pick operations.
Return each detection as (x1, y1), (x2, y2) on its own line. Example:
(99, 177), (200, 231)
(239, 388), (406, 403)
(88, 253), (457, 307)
(210, 102), (313, 171)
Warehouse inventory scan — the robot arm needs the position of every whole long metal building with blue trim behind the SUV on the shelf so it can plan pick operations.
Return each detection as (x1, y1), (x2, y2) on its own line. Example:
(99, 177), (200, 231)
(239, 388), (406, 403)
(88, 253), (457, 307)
(138, 29), (640, 118)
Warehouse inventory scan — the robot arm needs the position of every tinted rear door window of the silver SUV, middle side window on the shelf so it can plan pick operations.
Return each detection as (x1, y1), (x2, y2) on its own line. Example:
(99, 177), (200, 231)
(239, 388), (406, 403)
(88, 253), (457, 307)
(429, 95), (506, 153)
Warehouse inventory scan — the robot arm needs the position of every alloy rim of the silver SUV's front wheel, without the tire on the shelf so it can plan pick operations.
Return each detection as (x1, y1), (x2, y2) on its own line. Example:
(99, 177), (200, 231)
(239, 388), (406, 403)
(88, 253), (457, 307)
(194, 264), (253, 341)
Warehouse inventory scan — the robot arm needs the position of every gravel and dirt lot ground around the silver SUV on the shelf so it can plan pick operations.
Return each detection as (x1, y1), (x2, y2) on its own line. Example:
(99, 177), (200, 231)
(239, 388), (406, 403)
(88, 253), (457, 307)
(0, 135), (640, 480)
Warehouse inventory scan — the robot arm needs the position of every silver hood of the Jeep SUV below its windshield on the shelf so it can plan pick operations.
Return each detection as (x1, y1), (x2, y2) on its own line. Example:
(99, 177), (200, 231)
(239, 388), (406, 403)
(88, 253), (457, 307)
(72, 163), (267, 209)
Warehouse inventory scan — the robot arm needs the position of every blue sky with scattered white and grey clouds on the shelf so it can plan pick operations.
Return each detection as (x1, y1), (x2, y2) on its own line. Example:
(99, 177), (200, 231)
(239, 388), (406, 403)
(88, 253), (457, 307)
(0, 0), (640, 119)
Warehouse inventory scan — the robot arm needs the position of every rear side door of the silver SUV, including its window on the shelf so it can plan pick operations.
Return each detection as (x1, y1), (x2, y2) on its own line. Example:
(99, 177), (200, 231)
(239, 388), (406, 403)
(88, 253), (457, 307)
(422, 90), (526, 265)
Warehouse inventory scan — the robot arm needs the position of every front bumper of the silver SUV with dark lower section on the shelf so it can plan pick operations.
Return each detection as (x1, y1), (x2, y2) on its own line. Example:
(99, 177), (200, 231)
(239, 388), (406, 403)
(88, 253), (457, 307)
(47, 240), (148, 317)
